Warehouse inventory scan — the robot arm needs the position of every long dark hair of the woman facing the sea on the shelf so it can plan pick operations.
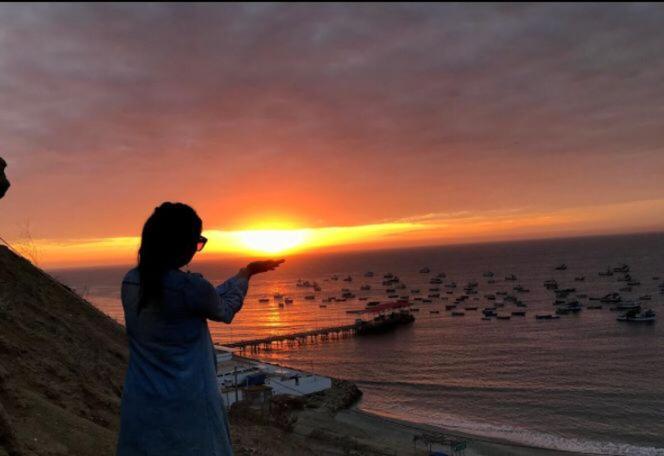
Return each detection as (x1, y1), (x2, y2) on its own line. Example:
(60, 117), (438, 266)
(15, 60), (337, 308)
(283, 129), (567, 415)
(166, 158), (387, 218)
(138, 203), (203, 313)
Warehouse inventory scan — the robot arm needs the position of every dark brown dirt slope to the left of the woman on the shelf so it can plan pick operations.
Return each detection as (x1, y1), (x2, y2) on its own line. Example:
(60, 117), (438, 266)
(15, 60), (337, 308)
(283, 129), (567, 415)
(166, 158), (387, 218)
(0, 246), (128, 456)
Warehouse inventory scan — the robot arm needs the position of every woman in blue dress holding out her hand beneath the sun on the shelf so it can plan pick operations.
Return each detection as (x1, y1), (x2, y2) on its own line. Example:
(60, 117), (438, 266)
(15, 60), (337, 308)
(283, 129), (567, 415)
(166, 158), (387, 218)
(117, 203), (283, 456)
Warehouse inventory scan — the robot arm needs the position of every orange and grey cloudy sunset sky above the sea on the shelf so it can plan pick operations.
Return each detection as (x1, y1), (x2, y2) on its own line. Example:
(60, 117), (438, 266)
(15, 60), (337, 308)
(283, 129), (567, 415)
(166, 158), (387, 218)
(0, 4), (664, 267)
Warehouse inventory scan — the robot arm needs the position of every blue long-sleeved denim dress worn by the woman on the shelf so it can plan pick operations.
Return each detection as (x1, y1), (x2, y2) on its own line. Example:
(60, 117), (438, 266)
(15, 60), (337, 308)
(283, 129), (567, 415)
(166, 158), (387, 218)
(117, 269), (248, 456)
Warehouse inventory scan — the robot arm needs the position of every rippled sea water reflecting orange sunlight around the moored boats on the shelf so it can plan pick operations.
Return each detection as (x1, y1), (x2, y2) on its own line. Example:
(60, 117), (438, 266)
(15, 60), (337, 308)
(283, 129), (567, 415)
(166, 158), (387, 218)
(51, 234), (664, 455)
